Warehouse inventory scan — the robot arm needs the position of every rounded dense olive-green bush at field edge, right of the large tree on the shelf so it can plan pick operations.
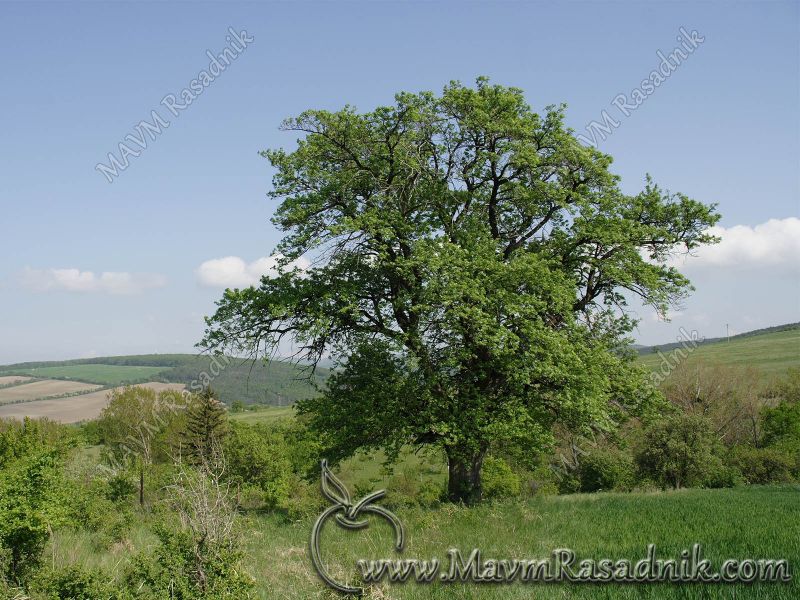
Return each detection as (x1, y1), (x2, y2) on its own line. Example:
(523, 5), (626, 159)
(636, 414), (722, 488)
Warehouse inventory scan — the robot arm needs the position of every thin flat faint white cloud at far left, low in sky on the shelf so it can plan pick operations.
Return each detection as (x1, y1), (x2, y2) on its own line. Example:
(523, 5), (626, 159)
(20, 268), (167, 294)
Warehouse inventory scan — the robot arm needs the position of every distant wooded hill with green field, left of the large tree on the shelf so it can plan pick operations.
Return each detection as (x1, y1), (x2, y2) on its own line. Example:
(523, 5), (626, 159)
(0, 354), (328, 406)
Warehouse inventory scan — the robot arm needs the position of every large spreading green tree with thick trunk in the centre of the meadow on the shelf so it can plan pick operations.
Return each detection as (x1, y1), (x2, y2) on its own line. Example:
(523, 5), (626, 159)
(202, 79), (718, 502)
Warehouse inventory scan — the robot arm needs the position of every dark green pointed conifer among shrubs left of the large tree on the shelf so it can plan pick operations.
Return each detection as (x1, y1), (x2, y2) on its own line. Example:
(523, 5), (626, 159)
(181, 387), (227, 463)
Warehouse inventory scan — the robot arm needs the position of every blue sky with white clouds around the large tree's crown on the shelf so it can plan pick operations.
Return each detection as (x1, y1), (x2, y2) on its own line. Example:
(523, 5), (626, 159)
(0, 1), (800, 364)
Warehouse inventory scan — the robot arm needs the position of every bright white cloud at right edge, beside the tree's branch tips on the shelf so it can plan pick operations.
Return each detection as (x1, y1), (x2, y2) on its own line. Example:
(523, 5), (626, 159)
(673, 217), (800, 270)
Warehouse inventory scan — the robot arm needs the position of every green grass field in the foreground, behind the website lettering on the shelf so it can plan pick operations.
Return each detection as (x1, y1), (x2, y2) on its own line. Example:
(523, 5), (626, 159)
(51, 485), (800, 600)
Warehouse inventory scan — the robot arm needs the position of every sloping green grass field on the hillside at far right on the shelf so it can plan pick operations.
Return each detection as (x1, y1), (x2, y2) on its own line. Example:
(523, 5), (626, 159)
(640, 329), (800, 378)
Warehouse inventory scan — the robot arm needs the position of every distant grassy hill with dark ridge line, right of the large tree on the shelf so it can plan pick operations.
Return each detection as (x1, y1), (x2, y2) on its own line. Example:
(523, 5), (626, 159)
(639, 323), (800, 377)
